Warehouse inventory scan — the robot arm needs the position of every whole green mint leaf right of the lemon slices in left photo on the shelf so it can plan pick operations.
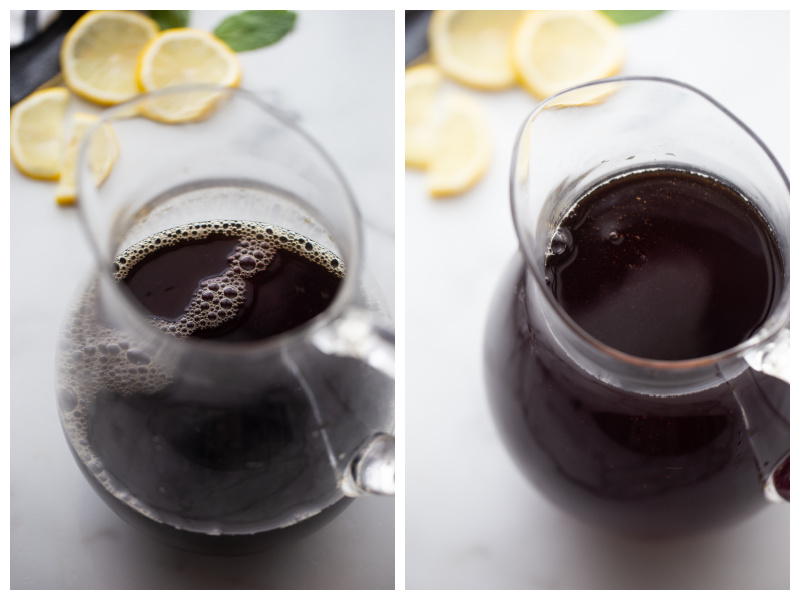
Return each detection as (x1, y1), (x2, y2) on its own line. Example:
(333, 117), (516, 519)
(214, 10), (297, 52)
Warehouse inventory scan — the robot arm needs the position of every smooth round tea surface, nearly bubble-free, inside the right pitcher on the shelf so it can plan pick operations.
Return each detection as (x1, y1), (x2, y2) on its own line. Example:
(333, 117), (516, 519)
(546, 169), (782, 360)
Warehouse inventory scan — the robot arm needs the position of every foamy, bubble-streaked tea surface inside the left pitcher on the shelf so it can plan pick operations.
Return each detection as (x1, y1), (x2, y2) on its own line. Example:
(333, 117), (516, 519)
(116, 222), (344, 342)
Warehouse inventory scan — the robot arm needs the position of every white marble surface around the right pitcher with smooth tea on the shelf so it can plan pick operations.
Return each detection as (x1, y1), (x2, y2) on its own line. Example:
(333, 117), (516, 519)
(405, 11), (789, 589)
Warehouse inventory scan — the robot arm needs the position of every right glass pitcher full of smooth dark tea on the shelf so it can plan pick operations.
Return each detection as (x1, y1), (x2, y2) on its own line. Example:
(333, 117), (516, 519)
(485, 79), (789, 536)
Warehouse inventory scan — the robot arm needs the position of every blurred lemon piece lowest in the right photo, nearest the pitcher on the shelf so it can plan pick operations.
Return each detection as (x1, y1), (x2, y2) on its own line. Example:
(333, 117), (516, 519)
(426, 92), (492, 197)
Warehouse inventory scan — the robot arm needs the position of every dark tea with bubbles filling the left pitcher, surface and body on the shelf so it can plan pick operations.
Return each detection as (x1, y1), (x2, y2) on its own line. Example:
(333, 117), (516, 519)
(59, 221), (389, 553)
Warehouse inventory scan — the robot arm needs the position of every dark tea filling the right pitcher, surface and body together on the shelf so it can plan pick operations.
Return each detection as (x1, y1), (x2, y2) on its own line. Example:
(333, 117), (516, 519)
(485, 167), (789, 536)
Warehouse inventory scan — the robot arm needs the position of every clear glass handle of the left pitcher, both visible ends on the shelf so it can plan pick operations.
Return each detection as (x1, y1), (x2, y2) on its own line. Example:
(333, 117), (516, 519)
(314, 307), (395, 497)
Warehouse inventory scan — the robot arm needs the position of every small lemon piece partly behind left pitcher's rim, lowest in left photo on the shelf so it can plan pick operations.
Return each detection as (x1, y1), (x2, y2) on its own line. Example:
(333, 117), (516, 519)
(56, 113), (119, 205)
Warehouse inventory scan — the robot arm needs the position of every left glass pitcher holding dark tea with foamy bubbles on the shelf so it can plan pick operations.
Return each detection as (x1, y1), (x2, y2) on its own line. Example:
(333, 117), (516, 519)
(57, 87), (394, 554)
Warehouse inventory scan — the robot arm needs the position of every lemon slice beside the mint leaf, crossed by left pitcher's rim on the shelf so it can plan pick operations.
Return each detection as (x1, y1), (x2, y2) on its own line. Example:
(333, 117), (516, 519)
(138, 28), (242, 123)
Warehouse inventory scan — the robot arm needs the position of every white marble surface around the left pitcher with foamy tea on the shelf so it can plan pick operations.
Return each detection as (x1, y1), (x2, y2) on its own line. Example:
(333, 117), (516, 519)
(10, 11), (395, 589)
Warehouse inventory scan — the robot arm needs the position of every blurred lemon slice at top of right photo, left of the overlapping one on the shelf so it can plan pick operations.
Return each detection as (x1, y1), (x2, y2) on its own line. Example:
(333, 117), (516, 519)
(428, 10), (524, 90)
